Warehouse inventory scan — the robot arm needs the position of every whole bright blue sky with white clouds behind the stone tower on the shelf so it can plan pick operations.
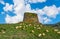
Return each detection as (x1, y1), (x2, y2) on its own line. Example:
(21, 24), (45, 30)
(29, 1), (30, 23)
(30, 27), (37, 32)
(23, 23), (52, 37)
(0, 0), (60, 24)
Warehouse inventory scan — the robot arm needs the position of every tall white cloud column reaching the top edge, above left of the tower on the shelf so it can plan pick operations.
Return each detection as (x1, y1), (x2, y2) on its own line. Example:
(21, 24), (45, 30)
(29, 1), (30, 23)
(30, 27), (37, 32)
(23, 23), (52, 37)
(13, 0), (25, 14)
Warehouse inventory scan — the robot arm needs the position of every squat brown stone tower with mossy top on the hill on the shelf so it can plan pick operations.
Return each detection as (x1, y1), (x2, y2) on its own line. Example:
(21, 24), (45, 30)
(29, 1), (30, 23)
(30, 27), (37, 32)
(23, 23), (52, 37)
(23, 12), (39, 23)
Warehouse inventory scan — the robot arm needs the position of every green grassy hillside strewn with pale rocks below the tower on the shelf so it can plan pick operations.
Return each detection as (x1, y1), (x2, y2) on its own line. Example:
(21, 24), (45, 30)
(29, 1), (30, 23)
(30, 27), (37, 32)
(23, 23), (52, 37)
(0, 23), (60, 39)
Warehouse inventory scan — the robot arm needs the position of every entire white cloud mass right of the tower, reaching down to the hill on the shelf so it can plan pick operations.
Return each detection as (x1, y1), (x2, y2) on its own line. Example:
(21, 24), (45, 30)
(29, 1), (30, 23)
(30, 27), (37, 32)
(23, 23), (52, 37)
(36, 5), (60, 23)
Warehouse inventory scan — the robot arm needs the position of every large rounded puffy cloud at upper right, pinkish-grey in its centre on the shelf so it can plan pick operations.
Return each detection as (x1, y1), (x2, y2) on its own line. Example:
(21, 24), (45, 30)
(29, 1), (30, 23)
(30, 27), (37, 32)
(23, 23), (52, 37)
(43, 5), (59, 18)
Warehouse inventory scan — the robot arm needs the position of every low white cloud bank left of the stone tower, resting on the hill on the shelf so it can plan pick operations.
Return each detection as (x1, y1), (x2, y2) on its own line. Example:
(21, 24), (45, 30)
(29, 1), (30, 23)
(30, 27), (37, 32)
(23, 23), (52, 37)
(5, 15), (23, 23)
